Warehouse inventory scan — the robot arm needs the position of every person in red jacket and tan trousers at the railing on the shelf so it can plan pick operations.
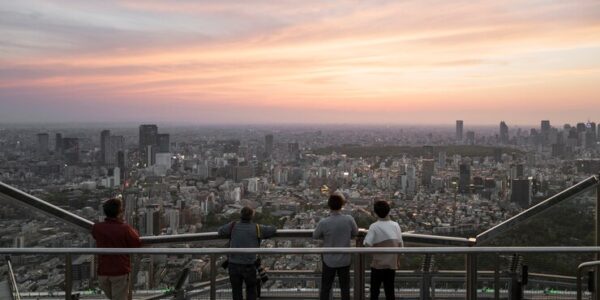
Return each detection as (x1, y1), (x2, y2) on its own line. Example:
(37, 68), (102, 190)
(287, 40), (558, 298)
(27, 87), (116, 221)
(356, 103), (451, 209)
(92, 198), (142, 300)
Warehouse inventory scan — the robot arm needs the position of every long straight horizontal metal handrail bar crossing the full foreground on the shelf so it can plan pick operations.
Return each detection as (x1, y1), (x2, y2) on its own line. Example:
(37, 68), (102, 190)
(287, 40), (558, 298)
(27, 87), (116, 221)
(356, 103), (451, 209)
(0, 246), (600, 255)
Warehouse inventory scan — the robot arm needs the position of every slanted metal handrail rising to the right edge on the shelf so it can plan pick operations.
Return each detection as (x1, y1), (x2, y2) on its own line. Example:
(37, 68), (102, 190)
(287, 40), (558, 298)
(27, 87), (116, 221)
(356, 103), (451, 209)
(476, 175), (600, 245)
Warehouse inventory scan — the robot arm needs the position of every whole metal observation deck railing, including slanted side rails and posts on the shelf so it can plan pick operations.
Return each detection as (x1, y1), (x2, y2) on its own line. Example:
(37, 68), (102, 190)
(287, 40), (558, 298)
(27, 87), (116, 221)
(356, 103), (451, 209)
(0, 176), (600, 300)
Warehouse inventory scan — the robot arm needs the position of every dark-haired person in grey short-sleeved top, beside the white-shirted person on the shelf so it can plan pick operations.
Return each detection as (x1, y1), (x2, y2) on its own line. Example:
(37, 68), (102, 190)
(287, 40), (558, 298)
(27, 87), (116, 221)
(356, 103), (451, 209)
(313, 194), (358, 300)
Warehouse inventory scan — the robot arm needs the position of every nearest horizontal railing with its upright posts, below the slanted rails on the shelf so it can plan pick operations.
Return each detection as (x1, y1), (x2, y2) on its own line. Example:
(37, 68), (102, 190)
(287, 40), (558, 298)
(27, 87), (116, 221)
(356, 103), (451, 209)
(0, 246), (600, 300)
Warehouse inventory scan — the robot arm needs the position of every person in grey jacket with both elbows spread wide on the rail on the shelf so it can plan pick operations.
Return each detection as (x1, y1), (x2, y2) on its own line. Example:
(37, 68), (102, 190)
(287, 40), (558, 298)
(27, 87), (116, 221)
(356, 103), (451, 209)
(218, 206), (277, 300)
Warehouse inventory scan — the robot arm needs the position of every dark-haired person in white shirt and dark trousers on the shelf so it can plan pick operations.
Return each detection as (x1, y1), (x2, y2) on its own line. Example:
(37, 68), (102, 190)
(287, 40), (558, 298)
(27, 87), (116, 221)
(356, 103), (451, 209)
(364, 201), (404, 300)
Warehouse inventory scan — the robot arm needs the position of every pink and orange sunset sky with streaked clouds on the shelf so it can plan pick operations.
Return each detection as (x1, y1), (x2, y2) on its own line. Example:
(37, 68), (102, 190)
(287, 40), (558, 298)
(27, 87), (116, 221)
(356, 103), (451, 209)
(0, 0), (600, 125)
